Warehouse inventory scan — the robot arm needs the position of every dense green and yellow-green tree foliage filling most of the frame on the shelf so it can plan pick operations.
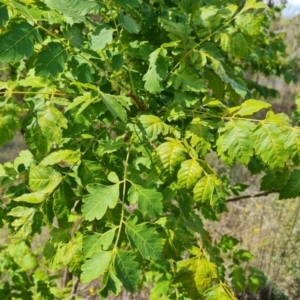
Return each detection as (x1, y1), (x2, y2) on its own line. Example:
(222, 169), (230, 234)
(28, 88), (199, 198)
(0, 0), (300, 300)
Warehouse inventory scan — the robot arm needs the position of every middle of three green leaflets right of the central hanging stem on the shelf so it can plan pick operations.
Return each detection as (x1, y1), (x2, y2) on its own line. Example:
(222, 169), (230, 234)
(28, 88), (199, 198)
(125, 218), (163, 259)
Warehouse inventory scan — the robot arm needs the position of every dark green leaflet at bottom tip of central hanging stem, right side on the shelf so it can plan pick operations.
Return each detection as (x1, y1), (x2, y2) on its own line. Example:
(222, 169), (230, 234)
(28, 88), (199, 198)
(114, 250), (141, 293)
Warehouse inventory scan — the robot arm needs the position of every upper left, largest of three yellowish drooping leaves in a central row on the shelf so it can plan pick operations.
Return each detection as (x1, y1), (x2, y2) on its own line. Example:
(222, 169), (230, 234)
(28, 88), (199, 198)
(155, 140), (186, 180)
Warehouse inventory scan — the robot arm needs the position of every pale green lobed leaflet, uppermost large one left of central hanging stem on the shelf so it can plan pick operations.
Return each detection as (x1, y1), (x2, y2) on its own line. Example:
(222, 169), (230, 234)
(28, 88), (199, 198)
(82, 184), (119, 221)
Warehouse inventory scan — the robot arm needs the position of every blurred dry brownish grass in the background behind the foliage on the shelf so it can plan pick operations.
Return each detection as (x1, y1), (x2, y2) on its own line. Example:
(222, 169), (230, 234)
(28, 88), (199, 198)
(0, 0), (300, 299)
